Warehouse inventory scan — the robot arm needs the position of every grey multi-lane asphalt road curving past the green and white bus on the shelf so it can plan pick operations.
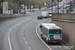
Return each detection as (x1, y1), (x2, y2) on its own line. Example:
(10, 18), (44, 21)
(0, 11), (71, 50)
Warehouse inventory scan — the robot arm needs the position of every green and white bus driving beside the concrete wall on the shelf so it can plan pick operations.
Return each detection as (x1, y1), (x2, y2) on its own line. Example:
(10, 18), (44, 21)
(40, 23), (62, 43)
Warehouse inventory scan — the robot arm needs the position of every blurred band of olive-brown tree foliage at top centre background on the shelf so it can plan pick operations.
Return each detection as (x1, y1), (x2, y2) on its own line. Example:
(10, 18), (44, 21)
(12, 0), (51, 7)
